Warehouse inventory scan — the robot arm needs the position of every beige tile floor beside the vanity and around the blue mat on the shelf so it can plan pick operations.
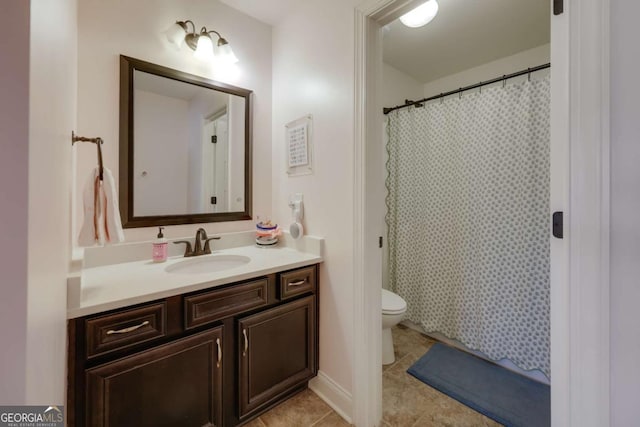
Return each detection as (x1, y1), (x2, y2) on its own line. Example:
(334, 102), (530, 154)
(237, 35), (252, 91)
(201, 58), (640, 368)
(246, 325), (500, 427)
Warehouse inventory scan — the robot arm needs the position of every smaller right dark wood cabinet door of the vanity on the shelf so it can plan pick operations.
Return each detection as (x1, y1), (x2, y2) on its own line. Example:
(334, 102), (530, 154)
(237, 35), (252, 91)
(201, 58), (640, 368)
(238, 296), (317, 420)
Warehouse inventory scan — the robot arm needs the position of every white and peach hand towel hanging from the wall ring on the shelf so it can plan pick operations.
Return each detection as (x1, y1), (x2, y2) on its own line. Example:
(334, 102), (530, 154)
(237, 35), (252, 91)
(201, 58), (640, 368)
(78, 168), (124, 246)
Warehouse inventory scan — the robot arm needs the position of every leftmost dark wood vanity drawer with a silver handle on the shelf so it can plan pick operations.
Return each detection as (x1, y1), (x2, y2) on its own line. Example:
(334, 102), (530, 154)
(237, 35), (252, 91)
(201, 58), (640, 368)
(86, 302), (167, 358)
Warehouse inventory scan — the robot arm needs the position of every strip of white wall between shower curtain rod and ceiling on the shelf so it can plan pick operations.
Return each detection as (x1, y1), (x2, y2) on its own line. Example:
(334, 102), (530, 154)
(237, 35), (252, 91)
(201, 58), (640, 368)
(423, 44), (551, 98)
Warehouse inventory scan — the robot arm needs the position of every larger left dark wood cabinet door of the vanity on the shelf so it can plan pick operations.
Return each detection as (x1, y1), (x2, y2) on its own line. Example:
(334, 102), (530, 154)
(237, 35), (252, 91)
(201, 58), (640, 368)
(86, 327), (222, 427)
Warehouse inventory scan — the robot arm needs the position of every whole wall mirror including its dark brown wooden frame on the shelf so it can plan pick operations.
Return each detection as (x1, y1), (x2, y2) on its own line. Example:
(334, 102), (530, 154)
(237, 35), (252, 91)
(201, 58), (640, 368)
(119, 55), (252, 228)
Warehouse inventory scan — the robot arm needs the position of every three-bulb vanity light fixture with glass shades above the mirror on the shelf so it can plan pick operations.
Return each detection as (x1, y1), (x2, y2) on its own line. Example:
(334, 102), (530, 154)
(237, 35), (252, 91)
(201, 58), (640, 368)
(164, 20), (239, 64)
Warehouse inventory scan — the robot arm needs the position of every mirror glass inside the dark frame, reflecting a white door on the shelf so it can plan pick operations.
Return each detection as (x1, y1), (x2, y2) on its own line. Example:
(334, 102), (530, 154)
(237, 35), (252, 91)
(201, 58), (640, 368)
(133, 70), (245, 216)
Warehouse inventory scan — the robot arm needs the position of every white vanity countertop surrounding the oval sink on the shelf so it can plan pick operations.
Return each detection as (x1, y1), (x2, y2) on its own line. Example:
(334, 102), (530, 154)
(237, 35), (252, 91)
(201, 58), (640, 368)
(67, 232), (323, 319)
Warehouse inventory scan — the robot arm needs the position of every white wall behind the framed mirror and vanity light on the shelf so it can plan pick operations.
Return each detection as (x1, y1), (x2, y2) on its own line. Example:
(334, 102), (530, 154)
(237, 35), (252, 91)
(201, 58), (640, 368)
(74, 0), (271, 241)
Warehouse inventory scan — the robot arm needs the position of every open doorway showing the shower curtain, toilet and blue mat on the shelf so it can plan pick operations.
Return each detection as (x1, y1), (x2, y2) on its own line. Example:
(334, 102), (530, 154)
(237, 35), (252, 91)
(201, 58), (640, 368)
(380, 0), (552, 426)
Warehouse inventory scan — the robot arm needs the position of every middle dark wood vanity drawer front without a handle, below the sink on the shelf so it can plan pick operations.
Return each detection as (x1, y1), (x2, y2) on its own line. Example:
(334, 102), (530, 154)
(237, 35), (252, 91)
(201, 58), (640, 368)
(184, 278), (268, 329)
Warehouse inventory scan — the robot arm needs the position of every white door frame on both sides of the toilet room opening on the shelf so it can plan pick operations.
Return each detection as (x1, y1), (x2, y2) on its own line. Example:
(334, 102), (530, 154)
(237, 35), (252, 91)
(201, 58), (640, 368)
(353, 0), (610, 427)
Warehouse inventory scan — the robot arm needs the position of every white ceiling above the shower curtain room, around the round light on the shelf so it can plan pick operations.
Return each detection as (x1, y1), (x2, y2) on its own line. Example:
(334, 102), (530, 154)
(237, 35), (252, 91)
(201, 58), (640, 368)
(383, 0), (551, 83)
